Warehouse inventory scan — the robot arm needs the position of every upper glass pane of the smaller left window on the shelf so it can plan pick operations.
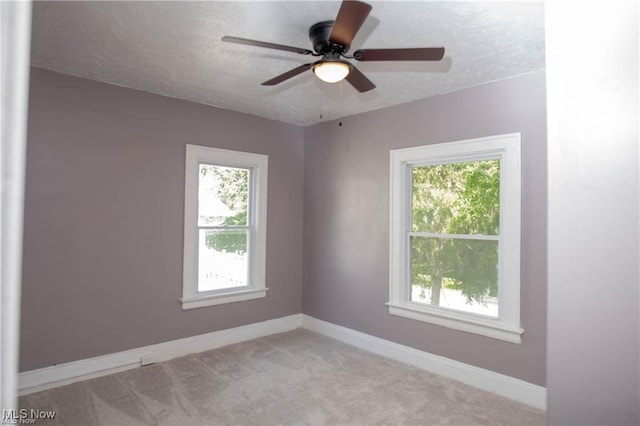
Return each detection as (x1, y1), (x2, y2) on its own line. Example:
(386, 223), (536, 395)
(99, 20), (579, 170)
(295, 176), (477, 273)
(198, 164), (249, 226)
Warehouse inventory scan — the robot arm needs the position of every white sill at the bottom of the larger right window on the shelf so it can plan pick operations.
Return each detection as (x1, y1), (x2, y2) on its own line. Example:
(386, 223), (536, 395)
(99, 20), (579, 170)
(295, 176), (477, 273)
(387, 302), (524, 344)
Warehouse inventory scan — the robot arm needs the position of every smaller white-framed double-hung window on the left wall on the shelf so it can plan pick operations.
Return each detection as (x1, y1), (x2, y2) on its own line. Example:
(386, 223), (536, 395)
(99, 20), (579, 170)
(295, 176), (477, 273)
(180, 145), (268, 309)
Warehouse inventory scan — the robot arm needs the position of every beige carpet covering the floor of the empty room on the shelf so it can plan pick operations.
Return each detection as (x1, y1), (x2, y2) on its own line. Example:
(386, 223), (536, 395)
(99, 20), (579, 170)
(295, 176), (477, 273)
(20, 329), (546, 426)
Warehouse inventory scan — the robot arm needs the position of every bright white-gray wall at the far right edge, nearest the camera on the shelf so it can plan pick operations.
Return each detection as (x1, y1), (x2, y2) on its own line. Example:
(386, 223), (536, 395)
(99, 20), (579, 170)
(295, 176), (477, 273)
(545, 0), (640, 426)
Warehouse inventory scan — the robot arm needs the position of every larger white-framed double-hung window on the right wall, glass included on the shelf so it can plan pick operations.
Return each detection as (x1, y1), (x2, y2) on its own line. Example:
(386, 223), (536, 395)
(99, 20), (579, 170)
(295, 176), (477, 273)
(388, 134), (523, 343)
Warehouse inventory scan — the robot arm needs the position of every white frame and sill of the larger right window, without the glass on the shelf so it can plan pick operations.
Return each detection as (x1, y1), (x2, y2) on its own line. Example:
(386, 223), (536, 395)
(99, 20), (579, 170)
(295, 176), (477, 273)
(387, 133), (524, 343)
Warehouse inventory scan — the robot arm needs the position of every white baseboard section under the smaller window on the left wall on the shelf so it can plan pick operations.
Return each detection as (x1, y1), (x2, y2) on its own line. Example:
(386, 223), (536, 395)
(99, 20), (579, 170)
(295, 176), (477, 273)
(18, 314), (302, 395)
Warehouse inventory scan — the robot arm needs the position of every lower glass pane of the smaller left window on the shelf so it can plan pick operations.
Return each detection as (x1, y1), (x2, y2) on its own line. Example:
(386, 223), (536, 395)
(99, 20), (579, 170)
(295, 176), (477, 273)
(198, 229), (249, 291)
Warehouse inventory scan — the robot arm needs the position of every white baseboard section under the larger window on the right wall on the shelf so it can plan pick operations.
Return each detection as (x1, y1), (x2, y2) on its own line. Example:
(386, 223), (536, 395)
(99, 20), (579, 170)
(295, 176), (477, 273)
(302, 314), (547, 410)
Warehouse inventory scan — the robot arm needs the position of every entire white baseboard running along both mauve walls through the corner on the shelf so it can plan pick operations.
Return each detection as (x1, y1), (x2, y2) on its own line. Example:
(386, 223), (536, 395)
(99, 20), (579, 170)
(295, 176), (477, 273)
(18, 314), (547, 410)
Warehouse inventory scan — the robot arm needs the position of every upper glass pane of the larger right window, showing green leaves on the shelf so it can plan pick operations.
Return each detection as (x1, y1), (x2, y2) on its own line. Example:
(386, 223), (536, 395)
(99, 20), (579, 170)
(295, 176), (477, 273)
(411, 160), (500, 235)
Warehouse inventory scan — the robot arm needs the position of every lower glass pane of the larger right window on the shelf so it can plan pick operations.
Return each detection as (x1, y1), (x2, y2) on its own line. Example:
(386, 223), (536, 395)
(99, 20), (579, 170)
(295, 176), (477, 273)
(410, 236), (498, 317)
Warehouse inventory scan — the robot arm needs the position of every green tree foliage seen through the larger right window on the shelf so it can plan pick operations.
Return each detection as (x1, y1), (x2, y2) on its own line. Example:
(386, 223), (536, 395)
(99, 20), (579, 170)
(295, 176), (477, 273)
(409, 159), (500, 312)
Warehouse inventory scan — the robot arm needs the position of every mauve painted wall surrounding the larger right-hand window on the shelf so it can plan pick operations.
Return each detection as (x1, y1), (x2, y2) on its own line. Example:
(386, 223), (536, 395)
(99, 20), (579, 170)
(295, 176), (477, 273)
(303, 71), (547, 386)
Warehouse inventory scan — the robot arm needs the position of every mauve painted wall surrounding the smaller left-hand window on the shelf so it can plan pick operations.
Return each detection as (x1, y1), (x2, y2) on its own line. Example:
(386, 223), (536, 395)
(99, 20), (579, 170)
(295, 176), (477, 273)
(20, 69), (304, 371)
